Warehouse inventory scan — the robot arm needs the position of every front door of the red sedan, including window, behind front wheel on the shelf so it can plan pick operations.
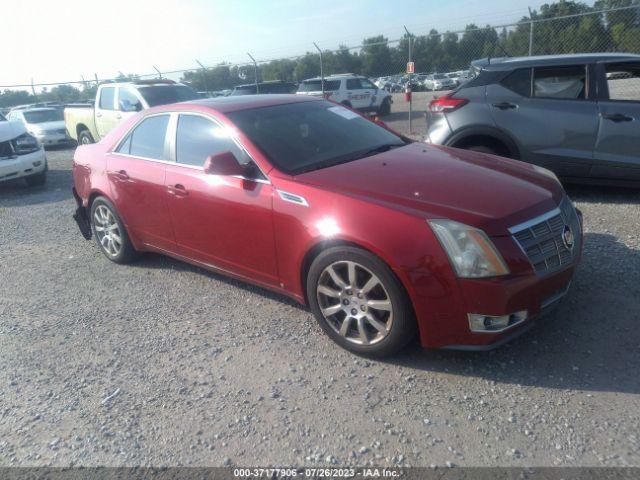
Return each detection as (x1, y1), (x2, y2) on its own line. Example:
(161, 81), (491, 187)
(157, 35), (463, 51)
(165, 113), (278, 285)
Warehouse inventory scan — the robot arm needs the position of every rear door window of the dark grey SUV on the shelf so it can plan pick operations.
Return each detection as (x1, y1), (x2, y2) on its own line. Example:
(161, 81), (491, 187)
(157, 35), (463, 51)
(533, 65), (587, 100)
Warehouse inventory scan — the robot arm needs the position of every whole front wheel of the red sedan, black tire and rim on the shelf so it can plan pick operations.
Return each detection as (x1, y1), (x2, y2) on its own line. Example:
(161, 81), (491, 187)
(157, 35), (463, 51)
(307, 246), (416, 357)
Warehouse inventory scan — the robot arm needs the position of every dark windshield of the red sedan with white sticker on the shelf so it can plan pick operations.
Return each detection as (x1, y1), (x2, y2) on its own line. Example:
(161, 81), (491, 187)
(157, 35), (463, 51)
(227, 101), (406, 175)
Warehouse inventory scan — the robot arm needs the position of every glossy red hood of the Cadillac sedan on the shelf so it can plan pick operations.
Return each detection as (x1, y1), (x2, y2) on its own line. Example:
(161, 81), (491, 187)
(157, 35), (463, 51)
(296, 142), (564, 236)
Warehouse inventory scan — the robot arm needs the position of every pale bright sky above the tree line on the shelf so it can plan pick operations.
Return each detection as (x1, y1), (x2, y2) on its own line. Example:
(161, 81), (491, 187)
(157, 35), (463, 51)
(0, 0), (572, 88)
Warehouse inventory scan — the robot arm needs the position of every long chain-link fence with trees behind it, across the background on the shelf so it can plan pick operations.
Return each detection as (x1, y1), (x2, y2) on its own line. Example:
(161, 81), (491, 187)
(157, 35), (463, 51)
(0, 0), (640, 137)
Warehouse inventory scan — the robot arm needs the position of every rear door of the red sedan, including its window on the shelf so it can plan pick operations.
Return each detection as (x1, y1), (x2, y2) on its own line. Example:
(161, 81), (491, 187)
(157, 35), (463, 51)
(107, 114), (175, 251)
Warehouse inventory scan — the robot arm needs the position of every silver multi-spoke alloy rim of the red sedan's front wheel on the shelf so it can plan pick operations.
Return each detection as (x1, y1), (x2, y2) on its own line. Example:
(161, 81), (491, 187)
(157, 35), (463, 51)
(316, 261), (393, 345)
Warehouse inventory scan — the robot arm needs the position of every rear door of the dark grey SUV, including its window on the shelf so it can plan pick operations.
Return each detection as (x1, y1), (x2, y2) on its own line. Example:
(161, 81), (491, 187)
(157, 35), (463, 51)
(487, 65), (598, 177)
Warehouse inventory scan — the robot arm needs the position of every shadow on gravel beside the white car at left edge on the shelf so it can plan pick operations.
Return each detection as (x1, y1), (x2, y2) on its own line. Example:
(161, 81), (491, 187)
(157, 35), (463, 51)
(0, 169), (73, 207)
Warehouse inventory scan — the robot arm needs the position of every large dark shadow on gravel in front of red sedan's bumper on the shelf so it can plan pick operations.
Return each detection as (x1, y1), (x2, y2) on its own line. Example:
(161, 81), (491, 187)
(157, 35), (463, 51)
(388, 233), (640, 394)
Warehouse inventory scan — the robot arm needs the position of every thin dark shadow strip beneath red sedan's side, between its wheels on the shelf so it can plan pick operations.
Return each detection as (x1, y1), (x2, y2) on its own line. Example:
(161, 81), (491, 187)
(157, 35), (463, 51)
(128, 253), (307, 311)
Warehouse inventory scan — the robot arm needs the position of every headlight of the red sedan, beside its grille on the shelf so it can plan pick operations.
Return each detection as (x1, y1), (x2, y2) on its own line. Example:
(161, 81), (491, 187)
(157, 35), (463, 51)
(428, 220), (509, 278)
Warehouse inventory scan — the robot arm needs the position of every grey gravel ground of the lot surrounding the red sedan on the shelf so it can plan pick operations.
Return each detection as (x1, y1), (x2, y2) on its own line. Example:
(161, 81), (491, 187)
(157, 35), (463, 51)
(0, 150), (640, 466)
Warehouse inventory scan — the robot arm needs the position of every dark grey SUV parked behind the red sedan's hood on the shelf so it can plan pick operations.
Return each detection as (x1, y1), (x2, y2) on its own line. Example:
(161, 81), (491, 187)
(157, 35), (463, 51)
(426, 53), (640, 185)
